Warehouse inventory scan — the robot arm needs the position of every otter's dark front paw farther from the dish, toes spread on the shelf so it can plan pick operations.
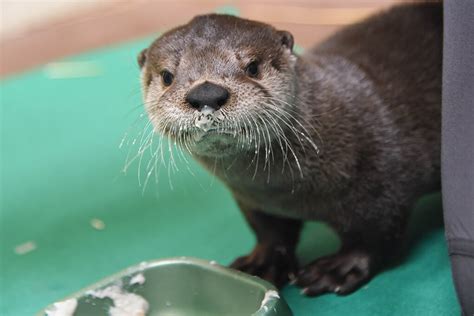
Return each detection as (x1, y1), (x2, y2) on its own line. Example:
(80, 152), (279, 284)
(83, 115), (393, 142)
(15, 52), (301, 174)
(294, 249), (376, 296)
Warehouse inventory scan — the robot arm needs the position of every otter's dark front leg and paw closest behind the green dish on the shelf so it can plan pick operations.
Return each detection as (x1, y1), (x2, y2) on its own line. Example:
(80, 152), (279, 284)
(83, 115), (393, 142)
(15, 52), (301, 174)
(231, 204), (301, 287)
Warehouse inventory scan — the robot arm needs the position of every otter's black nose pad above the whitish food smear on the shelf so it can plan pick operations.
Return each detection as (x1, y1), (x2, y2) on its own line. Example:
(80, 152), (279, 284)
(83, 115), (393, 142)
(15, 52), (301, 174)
(186, 81), (229, 110)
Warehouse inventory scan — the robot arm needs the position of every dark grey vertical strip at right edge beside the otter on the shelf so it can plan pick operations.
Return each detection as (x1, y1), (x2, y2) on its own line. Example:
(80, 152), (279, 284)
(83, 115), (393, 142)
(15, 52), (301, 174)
(442, 0), (474, 316)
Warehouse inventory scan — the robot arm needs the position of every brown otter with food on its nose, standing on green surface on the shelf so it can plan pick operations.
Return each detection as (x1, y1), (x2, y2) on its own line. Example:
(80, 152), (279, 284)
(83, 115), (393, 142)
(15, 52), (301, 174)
(138, 3), (443, 296)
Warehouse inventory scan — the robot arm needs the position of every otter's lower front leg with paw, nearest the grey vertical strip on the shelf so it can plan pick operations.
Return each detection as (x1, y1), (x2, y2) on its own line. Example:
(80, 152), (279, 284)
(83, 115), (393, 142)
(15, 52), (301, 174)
(294, 223), (401, 296)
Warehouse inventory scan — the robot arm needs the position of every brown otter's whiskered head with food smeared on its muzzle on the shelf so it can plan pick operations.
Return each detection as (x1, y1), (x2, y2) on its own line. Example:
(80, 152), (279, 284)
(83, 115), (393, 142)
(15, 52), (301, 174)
(138, 14), (296, 157)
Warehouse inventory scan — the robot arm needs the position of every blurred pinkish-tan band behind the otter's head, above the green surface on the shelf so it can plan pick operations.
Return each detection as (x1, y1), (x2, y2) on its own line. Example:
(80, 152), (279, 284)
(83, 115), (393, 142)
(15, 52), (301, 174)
(0, 0), (413, 76)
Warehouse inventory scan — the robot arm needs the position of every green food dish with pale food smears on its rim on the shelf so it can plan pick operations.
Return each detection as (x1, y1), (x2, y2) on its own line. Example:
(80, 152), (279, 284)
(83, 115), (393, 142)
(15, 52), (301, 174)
(37, 257), (293, 316)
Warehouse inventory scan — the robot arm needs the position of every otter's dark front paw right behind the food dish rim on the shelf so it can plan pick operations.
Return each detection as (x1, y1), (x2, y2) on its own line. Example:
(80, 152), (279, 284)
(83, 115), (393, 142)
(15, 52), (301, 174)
(230, 245), (298, 288)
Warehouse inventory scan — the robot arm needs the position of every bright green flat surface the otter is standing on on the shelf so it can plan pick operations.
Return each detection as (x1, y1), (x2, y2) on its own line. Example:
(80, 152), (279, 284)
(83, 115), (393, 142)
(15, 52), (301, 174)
(0, 34), (459, 316)
